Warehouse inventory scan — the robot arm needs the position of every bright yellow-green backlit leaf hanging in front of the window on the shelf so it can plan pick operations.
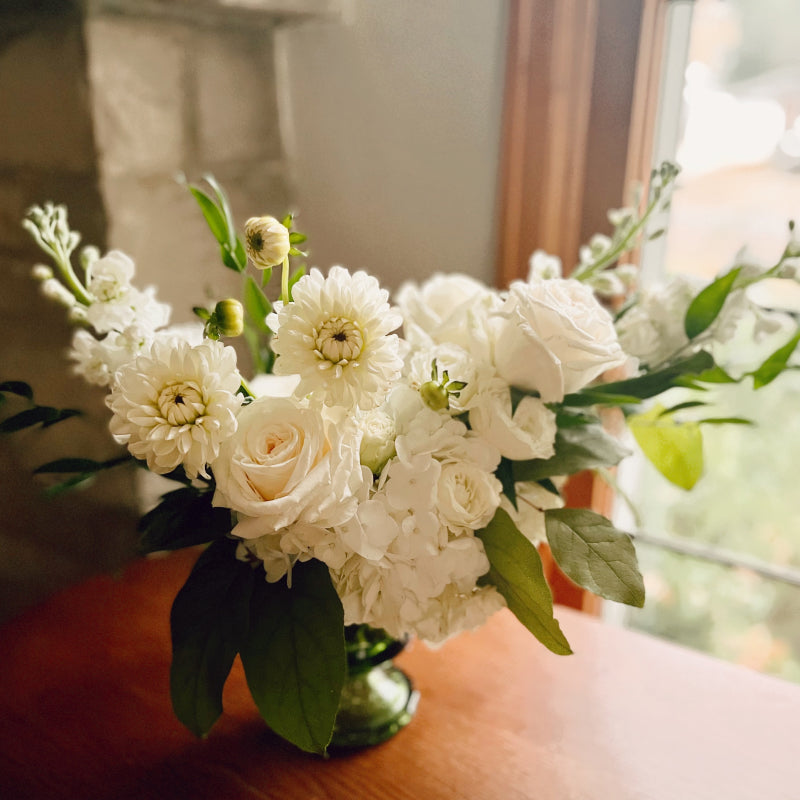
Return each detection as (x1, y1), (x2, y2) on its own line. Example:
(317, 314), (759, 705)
(628, 405), (703, 490)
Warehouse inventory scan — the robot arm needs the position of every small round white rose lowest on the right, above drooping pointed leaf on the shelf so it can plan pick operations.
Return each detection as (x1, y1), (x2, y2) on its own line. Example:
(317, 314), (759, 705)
(436, 461), (503, 533)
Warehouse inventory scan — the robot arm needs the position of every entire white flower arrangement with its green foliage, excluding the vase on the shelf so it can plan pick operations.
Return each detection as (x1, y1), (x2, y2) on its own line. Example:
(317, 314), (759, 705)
(7, 164), (800, 752)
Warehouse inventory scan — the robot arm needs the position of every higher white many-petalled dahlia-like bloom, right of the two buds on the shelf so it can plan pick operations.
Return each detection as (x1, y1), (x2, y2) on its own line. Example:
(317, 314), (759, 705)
(268, 267), (402, 410)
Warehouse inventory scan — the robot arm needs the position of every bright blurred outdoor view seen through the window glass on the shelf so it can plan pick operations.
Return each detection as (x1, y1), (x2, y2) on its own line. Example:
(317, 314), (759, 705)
(612, 0), (800, 681)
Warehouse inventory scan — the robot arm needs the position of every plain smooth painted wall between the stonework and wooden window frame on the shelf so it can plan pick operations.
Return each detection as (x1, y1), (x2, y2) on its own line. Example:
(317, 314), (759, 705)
(277, 0), (507, 288)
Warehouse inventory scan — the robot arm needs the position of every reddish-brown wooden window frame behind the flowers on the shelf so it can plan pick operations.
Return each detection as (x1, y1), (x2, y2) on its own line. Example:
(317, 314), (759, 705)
(496, 0), (669, 614)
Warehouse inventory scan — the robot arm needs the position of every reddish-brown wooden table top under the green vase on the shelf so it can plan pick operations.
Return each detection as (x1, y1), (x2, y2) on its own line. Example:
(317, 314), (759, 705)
(0, 552), (800, 800)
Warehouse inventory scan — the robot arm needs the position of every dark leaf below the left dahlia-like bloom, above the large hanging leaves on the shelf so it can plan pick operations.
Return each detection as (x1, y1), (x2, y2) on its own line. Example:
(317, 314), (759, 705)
(138, 486), (232, 553)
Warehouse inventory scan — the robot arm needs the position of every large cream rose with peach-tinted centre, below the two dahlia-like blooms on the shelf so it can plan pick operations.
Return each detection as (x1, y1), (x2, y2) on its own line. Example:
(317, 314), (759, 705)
(214, 397), (364, 539)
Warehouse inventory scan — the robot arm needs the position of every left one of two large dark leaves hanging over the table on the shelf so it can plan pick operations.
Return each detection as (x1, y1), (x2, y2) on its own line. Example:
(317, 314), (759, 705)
(170, 539), (255, 736)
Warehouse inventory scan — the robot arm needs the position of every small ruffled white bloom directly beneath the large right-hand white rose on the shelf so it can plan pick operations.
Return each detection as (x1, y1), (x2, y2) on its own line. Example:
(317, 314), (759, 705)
(469, 380), (556, 461)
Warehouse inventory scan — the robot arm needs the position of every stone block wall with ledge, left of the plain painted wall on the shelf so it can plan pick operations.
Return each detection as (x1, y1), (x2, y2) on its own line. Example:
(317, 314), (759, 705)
(0, 0), (334, 618)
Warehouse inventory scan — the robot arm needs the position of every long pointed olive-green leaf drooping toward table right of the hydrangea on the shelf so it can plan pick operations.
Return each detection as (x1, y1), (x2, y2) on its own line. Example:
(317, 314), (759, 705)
(477, 509), (572, 655)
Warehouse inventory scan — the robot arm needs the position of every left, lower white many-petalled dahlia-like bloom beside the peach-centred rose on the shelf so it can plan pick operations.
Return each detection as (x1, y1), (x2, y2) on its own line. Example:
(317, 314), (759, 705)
(106, 341), (241, 478)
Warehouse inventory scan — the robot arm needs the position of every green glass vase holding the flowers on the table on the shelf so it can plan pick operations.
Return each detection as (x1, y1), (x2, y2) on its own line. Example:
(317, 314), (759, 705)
(330, 625), (419, 750)
